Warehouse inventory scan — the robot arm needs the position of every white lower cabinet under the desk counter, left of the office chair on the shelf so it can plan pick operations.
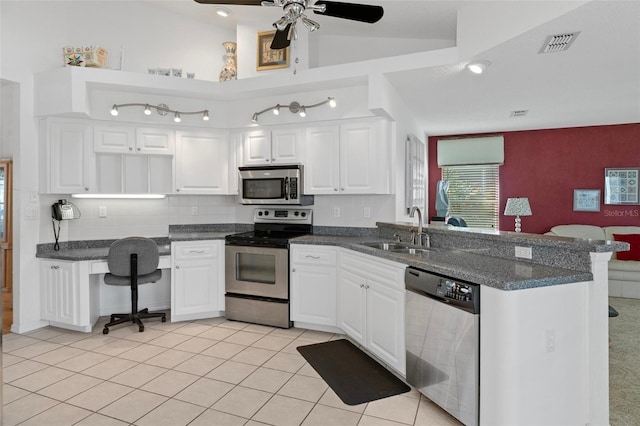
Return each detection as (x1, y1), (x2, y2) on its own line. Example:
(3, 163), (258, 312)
(40, 260), (97, 331)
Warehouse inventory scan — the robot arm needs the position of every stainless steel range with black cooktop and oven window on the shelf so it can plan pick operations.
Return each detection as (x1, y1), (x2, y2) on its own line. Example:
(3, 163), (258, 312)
(225, 208), (313, 328)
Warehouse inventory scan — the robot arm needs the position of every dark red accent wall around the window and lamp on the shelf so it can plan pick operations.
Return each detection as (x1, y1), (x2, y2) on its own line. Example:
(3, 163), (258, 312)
(428, 123), (640, 234)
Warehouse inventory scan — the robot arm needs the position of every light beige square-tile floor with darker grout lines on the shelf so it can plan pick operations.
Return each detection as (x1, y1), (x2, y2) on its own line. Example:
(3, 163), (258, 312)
(2, 318), (460, 426)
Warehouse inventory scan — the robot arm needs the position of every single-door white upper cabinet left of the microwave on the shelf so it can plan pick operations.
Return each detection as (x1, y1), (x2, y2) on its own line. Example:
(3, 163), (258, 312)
(175, 131), (232, 194)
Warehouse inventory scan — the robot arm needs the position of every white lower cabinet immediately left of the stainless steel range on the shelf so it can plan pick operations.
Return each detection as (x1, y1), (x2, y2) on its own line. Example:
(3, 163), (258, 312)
(171, 240), (224, 322)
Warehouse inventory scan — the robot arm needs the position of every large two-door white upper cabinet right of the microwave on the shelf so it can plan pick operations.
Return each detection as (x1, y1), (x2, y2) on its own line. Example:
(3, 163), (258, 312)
(303, 119), (391, 195)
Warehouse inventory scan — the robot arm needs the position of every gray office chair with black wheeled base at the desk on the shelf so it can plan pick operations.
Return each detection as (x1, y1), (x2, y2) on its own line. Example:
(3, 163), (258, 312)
(102, 237), (167, 334)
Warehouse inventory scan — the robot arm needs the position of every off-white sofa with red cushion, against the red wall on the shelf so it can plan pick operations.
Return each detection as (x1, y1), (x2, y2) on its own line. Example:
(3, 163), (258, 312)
(545, 225), (640, 299)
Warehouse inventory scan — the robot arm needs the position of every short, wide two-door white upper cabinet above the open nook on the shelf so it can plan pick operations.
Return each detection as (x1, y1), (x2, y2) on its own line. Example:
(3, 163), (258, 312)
(93, 125), (174, 155)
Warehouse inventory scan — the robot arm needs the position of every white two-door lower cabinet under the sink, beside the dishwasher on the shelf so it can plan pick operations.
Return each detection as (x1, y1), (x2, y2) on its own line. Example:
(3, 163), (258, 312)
(338, 250), (406, 375)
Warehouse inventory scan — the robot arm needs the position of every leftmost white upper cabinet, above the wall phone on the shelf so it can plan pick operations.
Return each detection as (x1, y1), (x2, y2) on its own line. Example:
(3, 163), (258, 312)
(40, 119), (95, 194)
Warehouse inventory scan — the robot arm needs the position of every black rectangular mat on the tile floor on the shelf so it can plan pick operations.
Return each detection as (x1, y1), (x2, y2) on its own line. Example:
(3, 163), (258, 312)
(297, 339), (410, 405)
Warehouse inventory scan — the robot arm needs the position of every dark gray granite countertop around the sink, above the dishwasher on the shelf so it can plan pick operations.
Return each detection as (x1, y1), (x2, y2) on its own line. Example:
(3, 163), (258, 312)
(291, 235), (593, 290)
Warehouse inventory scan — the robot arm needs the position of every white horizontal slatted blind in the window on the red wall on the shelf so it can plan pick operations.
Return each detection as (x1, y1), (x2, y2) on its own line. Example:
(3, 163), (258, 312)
(442, 164), (500, 229)
